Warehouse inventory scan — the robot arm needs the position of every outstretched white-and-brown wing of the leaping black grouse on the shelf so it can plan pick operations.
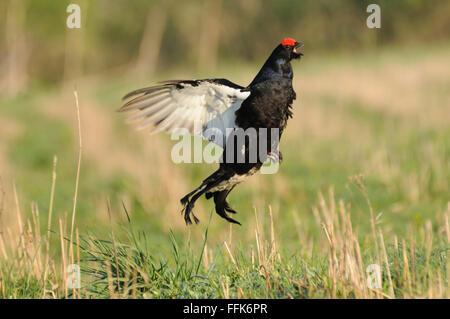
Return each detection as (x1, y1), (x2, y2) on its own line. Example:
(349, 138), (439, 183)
(119, 79), (250, 147)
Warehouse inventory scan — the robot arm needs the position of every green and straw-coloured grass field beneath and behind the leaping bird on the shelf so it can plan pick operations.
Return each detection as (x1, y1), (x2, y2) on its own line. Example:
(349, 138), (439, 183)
(0, 45), (450, 298)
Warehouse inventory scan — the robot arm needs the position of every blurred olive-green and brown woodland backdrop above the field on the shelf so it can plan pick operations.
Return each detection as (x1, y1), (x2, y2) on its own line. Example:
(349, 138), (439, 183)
(0, 0), (450, 85)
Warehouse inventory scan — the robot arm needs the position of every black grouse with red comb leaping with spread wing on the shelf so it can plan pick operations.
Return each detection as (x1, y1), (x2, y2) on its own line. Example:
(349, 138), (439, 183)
(119, 38), (303, 224)
